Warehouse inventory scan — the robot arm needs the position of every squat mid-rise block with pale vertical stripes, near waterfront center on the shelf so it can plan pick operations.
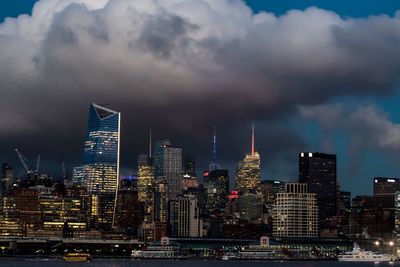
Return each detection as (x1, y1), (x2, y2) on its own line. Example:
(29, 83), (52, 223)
(169, 195), (203, 237)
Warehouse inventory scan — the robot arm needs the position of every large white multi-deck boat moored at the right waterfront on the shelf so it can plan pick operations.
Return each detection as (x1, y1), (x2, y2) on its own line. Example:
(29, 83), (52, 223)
(338, 243), (396, 262)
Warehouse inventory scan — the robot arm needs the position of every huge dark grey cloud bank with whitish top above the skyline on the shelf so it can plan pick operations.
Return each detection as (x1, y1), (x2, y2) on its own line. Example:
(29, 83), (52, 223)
(0, 0), (400, 180)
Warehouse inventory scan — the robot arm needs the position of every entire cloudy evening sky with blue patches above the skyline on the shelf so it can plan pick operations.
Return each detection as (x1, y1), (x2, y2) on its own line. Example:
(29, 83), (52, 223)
(0, 0), (400, 195)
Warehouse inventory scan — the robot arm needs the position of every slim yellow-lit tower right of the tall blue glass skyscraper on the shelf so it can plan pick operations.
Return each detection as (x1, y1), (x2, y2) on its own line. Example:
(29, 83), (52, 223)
(137, 155), (154, 222)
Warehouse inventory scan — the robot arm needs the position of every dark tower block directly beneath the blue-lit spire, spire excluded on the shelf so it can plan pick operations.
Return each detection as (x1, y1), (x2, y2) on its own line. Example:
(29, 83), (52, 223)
(204, 170), (229, 210)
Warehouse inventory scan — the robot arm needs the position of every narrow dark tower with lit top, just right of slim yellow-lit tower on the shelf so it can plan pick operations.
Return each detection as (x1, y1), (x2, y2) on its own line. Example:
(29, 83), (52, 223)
(154, 177), (169, 223)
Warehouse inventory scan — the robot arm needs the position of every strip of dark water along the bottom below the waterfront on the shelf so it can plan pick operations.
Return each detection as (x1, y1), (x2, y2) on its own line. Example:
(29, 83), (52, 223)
(0, 259), (400, 267)
